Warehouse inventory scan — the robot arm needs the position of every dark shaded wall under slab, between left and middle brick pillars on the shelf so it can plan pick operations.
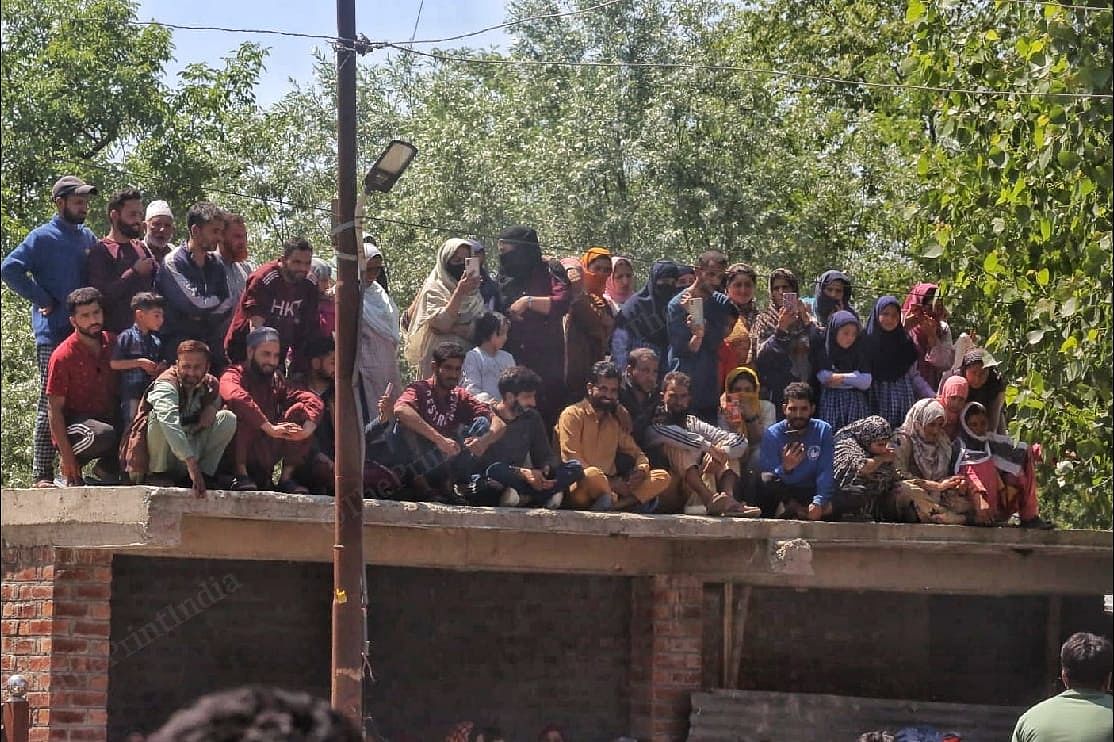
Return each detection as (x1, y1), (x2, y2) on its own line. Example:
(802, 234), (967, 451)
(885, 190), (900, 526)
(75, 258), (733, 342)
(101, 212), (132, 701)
(108, 556), (631, 742)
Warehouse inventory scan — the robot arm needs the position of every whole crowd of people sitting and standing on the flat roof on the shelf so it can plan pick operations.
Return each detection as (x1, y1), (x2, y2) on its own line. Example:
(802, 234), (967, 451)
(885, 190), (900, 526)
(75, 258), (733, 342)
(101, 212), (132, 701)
(0, 176), (1051, 528)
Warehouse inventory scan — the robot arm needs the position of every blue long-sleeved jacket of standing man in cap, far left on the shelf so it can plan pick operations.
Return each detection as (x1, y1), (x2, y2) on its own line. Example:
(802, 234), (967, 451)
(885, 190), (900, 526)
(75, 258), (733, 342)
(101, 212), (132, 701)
(0, 215), (97, 345)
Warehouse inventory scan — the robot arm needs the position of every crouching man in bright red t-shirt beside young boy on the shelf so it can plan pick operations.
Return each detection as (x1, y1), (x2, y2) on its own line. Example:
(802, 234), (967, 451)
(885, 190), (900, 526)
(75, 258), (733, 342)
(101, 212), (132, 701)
(47, 287), (119, 487)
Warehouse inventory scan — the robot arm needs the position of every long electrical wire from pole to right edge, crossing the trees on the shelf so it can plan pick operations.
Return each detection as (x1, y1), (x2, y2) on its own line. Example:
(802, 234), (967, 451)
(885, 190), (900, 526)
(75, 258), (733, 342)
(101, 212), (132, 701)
(385, 43), (1114, 100)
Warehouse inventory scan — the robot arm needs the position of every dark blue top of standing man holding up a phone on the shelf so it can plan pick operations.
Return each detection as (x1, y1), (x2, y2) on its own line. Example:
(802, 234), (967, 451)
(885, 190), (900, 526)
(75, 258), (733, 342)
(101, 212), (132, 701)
(665, 291), (739, 412)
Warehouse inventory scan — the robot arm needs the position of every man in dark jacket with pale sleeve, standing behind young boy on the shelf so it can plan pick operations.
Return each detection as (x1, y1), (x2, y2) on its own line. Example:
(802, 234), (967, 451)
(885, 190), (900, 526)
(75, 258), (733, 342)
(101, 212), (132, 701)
(157, 201), (233, 371)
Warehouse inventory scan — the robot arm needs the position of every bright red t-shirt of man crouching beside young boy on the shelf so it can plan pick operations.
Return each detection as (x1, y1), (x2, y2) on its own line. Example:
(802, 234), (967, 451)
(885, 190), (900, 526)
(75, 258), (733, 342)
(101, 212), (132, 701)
(47, 331), (117, 422)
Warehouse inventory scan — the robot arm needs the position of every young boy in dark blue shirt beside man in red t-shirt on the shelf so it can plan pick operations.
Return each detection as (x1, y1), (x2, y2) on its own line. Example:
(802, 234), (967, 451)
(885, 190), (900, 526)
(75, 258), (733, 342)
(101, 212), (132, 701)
(109, 291), (168, 430)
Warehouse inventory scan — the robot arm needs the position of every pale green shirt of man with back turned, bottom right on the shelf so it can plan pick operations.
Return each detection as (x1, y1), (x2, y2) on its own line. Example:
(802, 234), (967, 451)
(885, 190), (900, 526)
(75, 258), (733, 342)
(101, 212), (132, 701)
(1013, 689), (1114, 742)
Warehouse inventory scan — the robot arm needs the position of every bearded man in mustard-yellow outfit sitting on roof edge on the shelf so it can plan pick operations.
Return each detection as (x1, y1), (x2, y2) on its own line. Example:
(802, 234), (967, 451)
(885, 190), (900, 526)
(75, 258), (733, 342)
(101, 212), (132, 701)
(557, 361), (670, 512)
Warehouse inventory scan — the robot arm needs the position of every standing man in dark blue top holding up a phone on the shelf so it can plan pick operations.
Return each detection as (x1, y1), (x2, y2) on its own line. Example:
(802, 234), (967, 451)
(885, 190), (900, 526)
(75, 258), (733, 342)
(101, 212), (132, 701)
(666, 250), (739, 424)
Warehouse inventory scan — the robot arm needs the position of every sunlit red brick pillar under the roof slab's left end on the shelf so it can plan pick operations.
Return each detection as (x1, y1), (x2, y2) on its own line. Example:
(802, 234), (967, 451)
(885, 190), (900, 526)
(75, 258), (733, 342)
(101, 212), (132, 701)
(0, 547), (113, 742)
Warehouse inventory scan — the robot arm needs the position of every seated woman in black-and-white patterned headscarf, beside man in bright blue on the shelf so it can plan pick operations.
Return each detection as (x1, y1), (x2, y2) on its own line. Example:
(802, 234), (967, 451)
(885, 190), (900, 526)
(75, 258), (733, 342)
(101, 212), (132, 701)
(832, 414), (898, 520)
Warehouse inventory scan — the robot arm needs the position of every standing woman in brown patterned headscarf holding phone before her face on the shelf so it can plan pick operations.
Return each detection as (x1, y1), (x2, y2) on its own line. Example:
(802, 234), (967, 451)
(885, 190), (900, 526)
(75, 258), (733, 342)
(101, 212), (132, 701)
(752, 269), (812, 412)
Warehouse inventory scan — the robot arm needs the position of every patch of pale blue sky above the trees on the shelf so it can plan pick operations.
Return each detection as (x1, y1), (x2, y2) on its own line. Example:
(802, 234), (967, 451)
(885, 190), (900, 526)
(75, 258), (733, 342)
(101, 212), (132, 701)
(136, 0), (508, 106)
